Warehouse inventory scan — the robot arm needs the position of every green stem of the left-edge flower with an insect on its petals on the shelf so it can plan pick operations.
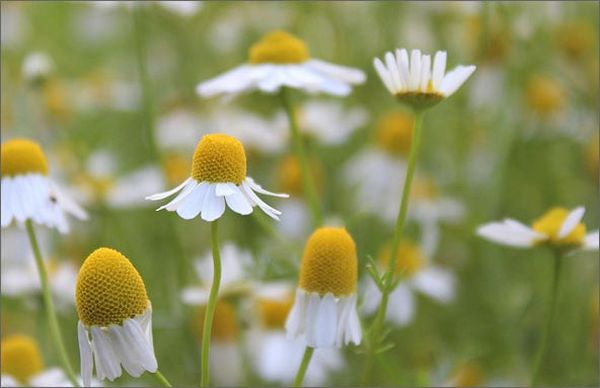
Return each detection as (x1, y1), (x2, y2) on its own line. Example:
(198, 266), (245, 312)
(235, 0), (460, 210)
(25, 220), (79, 387)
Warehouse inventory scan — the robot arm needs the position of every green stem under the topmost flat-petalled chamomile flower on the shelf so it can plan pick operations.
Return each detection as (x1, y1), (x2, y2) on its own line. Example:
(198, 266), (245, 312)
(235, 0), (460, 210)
(279, 87), (323, 227)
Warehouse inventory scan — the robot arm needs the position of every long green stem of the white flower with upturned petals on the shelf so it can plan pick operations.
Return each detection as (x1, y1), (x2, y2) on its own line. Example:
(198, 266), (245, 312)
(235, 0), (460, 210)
(362, 110), (425, 384)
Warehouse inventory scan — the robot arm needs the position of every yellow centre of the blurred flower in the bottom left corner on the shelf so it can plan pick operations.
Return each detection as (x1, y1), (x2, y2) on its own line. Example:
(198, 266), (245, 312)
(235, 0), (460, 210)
(0, 335), (44, 384)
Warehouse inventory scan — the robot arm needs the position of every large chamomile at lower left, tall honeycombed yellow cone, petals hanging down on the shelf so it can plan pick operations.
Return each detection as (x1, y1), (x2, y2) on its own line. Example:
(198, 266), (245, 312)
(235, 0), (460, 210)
(76, 248), (158, 386)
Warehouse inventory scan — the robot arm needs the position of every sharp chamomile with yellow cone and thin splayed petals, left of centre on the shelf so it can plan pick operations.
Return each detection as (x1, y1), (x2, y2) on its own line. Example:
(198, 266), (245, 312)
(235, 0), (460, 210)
(146, 134), (288, 222)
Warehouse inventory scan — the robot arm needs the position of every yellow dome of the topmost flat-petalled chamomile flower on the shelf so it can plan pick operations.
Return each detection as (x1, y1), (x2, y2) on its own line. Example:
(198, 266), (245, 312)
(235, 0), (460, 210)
(250, 30), (309, 63)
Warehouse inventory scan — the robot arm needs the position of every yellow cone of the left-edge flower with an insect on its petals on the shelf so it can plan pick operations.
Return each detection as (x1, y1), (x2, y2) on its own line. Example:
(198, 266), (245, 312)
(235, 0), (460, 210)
(0, 139), (48, 176)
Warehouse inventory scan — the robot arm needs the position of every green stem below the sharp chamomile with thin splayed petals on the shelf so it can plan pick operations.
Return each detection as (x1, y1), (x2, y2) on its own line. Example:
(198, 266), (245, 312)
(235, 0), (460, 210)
(200, 220), (221, 387)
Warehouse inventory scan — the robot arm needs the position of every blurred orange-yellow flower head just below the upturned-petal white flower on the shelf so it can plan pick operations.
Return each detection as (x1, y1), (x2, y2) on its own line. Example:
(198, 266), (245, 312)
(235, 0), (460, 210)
(376, 112), (414, 155)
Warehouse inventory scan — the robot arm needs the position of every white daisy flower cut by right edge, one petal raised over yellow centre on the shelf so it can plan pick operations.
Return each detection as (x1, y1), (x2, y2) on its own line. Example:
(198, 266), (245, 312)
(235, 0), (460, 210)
(477, 207), (598, 250)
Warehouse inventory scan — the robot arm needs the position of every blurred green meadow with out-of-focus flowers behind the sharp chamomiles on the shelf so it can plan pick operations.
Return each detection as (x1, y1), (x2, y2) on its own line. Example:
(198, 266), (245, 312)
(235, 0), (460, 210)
(0, 1), (600, 386)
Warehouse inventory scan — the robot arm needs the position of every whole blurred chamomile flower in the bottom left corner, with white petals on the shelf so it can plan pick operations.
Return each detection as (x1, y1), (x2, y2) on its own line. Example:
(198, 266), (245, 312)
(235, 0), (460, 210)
(0, 334), (84, 387)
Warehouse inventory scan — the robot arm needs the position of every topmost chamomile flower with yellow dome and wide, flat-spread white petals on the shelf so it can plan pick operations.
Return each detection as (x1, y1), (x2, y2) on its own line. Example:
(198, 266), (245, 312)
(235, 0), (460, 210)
(196, 30), (365, 97)
